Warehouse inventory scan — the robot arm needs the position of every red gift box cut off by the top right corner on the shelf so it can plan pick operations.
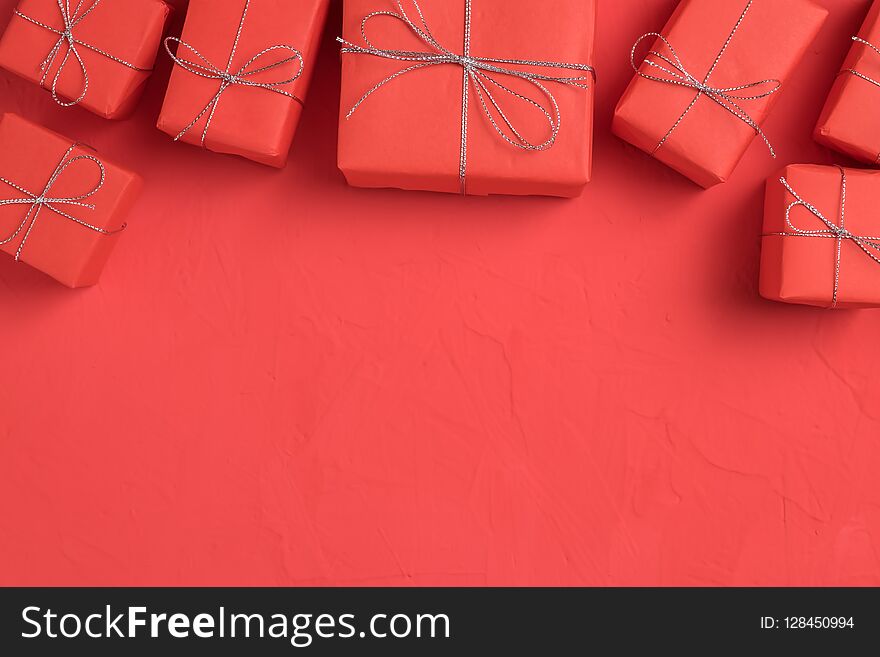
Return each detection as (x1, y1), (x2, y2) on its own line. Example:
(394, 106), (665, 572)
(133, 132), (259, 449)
(815, 2), (880, 164)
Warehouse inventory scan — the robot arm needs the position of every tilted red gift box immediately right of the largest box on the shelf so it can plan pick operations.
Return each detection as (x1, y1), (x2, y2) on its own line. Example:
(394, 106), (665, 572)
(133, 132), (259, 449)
(612, 0), (828, 188)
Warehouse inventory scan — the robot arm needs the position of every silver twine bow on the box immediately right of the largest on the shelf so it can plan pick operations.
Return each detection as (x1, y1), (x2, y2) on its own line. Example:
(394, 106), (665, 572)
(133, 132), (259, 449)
(630, 0), (782, 158)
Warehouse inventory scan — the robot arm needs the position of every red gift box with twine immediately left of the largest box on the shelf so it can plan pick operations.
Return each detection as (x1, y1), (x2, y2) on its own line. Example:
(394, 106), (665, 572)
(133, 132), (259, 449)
(158, 0), (329, 168)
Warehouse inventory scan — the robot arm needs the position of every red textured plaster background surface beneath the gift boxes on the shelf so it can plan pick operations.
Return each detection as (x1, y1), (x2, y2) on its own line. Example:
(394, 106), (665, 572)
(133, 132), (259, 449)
(0, 0), (880, 585)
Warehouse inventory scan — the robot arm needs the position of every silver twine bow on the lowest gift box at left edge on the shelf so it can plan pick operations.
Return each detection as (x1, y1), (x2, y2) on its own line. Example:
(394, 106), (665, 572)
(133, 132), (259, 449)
(0, 144), (125, 260)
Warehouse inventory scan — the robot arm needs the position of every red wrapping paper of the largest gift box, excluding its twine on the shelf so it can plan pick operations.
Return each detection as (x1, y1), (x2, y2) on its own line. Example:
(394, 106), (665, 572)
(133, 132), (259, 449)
(338, 0), (596, 197)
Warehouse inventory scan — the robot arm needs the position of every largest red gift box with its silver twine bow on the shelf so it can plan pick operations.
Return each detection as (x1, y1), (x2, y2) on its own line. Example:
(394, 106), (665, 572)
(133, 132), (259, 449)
(338, 0), (596, 197)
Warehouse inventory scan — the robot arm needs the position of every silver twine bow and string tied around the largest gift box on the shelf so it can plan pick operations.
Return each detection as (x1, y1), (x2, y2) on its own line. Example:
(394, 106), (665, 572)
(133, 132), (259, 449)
(337, 0), (596, 194)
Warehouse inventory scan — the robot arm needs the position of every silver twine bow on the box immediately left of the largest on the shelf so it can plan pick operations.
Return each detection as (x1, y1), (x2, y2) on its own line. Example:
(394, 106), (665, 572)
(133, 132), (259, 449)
(165, 0), (303, 146)
